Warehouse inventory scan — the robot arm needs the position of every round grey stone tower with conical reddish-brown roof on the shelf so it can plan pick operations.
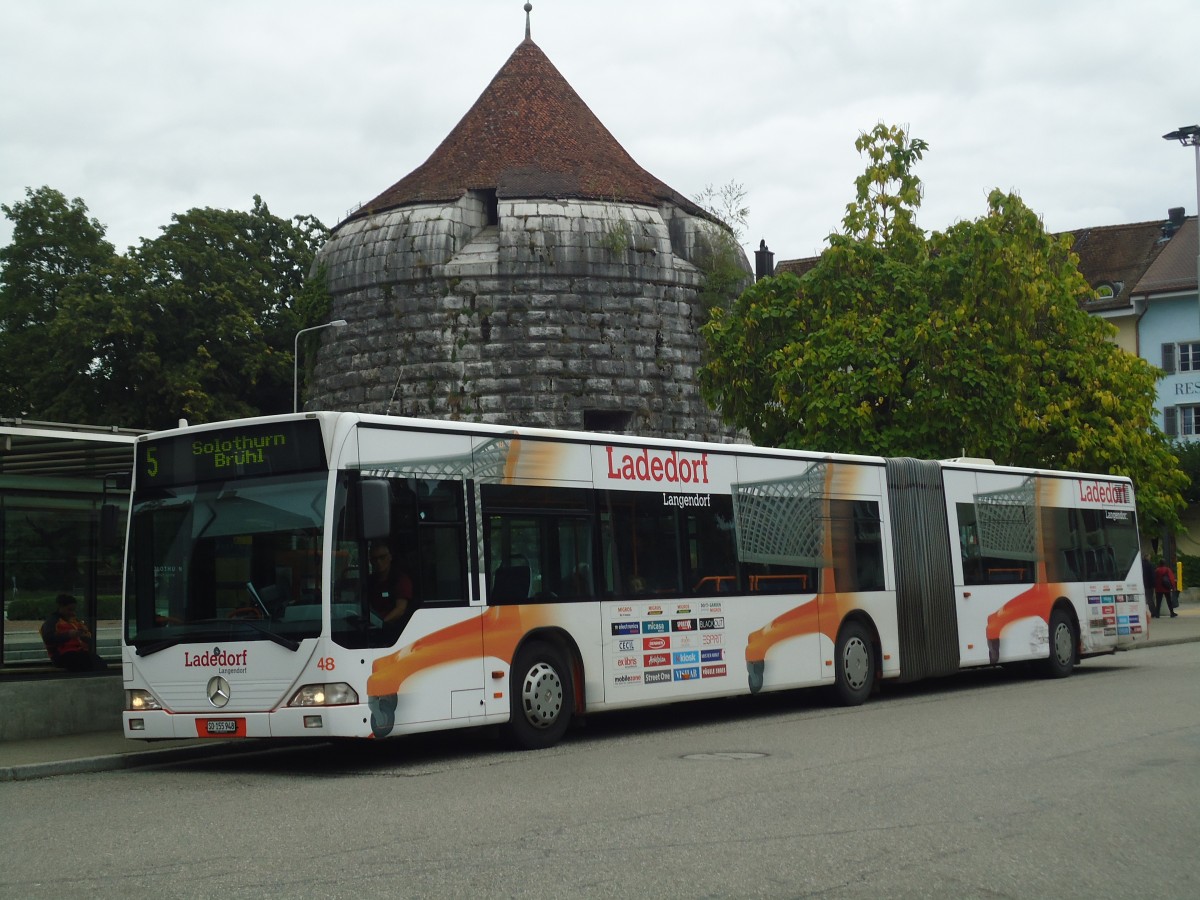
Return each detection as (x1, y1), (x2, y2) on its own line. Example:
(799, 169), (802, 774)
(305, 4), (750, 440)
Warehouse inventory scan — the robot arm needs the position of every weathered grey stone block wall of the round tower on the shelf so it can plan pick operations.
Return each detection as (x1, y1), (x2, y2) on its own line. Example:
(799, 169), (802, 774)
(305, 197), (749, 440)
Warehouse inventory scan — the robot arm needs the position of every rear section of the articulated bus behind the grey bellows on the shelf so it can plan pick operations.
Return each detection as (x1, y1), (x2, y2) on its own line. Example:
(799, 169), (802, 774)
(946, 467), (1148, 677)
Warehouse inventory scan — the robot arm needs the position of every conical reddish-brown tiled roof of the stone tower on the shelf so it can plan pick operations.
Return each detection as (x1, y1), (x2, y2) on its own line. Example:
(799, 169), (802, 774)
(340, 37), (710, 226)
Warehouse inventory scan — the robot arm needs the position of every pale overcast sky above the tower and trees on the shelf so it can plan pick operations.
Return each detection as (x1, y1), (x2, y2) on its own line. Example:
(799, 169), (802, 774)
(0, 0), (1200, 260)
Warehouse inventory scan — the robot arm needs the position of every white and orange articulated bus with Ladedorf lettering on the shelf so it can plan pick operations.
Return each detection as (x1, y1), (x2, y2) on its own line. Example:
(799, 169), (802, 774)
(122, 413), (1148, 749)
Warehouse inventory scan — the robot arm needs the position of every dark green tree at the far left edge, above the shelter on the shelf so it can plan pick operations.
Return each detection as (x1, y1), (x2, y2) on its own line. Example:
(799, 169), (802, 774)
(0, 187), (115, 419)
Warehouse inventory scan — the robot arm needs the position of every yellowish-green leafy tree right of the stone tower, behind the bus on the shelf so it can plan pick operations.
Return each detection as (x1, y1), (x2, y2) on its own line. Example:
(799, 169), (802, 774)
(701, 125), (1186, 533)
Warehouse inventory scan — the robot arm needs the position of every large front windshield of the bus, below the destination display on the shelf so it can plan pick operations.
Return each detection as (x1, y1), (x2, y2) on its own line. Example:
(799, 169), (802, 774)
(125, 472), (328, 655)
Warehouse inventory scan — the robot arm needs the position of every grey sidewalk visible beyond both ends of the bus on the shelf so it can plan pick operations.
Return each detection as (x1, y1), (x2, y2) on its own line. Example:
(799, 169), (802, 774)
(0, 602), (1200, 781)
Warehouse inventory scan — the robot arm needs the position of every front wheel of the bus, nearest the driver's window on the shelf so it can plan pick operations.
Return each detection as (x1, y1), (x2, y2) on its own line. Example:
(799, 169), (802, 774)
(508, 641), (575, 750)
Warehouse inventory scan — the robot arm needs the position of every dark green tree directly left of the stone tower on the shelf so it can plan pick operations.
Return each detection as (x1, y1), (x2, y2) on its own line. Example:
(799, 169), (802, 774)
(50, 196), (328, 427)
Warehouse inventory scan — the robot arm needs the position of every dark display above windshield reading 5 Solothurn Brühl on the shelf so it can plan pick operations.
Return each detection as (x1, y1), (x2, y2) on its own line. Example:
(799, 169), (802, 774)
(137, 419), (325, 487)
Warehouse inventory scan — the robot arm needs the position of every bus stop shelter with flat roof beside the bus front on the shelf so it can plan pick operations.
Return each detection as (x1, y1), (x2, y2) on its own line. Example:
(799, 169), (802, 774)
(0, 418), (144, 673)
